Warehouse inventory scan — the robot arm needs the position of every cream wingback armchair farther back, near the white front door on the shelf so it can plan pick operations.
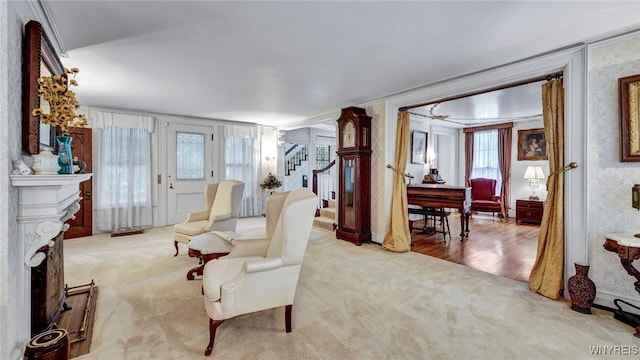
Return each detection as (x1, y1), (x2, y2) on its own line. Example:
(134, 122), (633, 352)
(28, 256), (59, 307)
(173, 180), (244, 256)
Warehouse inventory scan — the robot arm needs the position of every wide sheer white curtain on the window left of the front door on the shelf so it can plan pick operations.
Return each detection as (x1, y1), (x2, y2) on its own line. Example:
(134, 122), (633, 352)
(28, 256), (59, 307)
(92, 112), (153, 232)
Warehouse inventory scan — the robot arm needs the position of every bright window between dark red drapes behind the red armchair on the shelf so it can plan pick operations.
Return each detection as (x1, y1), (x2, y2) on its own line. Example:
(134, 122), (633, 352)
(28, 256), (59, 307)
(471, 129), (502, 195)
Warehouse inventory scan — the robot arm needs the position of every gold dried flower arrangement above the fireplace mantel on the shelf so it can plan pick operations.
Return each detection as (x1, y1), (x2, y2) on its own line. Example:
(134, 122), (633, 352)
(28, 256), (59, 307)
(31, 68), (88, 136)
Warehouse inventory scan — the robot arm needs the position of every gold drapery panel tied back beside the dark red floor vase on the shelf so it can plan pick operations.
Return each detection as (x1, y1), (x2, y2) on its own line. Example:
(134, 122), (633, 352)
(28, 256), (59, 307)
(529, 79), (564, 300)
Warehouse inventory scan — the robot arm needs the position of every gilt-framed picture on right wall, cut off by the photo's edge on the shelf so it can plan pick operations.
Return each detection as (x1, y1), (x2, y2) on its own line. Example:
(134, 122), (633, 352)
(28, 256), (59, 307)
(618, 75), (640, 162)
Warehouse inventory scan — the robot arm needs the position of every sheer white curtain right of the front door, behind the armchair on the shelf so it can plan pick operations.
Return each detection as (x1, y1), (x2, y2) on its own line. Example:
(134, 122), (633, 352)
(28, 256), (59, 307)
(224, 125), (262, 216)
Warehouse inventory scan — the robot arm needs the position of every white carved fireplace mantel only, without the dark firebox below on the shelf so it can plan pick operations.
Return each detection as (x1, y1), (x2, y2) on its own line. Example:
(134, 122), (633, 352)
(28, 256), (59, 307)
(9, 174), (92, 267)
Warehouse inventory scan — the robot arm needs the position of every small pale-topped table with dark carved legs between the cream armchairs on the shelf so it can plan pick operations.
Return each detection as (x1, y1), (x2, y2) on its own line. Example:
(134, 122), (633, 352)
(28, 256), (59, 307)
(187, 233), (235, 280)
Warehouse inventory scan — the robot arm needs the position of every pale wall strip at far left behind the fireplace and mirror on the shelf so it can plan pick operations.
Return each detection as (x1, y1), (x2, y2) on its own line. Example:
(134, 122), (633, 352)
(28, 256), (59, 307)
(0, 1), (47, 359)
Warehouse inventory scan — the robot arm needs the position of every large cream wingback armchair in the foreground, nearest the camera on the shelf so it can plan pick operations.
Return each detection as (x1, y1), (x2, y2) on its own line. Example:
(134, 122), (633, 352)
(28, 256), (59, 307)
(202, 188), (318, 356)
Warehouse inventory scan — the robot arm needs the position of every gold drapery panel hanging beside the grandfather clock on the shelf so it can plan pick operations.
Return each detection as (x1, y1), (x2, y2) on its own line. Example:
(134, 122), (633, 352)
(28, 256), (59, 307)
(382, 111), (411, 252)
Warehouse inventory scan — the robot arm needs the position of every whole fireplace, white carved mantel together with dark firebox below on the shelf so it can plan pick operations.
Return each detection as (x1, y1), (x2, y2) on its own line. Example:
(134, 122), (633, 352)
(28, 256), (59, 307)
(10, 174), (92, 335)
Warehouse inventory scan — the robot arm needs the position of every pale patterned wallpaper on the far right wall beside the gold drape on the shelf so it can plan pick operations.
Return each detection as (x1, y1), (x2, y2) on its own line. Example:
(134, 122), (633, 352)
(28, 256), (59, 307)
(586, 33), (640, 301)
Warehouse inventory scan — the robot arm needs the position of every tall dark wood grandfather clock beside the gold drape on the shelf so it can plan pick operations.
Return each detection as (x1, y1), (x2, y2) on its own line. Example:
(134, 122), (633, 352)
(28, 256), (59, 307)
(336, 107), (371, 245)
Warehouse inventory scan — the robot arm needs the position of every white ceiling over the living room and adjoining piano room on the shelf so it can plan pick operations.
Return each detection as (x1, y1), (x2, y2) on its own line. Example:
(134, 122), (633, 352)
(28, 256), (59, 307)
(46, 1), (640, 127)
